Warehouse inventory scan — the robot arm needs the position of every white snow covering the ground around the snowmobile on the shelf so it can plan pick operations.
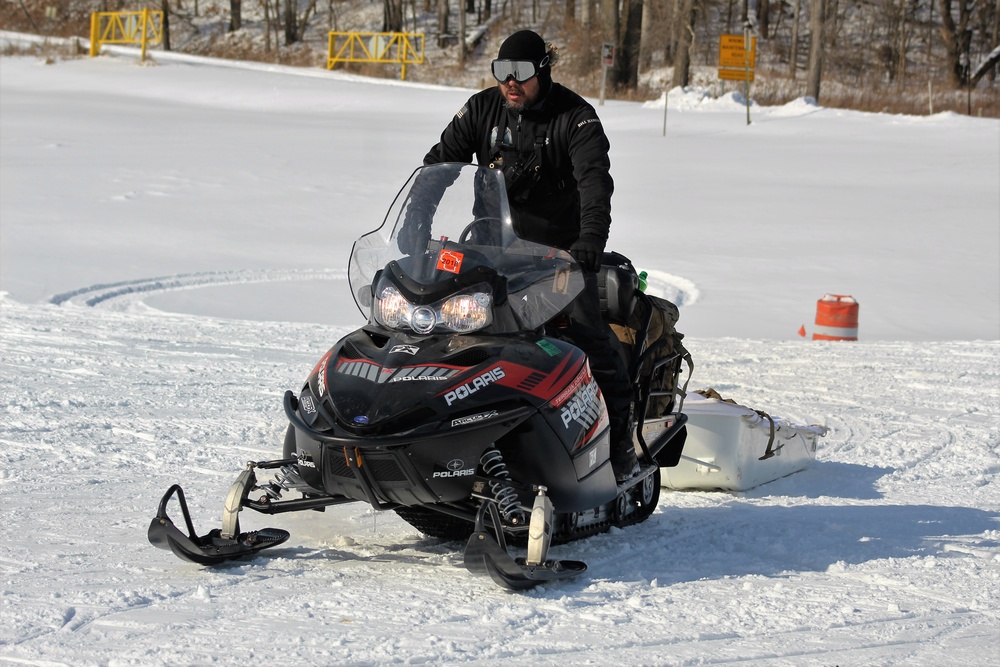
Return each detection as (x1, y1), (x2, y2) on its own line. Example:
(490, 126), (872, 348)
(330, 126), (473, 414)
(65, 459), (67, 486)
(0, 43), (1000, 666)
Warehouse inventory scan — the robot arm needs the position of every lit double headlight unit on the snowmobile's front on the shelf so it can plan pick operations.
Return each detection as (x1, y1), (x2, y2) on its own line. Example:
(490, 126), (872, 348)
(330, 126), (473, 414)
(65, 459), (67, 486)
(372, 284), (493, 334)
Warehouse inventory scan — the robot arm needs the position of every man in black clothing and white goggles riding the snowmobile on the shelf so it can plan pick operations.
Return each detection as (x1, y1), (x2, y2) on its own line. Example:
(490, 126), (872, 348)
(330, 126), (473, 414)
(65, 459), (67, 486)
(424, 30), (639, 481)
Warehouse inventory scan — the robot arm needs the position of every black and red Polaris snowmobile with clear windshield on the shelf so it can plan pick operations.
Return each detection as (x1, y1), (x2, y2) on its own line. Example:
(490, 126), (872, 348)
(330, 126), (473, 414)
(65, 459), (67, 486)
(148, 164), (686, 590)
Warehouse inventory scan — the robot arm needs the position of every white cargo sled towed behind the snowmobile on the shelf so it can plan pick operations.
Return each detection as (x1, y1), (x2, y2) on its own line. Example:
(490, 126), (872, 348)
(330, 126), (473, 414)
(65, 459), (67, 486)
(660, 392), (827, 491)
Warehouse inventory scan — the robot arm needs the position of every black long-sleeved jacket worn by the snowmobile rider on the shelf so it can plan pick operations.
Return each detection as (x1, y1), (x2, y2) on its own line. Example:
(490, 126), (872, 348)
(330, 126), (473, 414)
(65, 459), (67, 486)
(424, 83), (614, 249)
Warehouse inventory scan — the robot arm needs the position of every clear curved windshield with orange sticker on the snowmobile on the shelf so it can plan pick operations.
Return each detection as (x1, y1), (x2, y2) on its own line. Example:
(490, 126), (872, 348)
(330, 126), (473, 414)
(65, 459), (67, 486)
(348, 163), (583, 329)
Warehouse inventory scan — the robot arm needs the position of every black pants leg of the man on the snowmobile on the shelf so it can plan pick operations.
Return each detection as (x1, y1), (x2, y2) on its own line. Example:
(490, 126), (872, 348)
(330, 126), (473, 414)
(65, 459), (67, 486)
(559, 271), (632, 449)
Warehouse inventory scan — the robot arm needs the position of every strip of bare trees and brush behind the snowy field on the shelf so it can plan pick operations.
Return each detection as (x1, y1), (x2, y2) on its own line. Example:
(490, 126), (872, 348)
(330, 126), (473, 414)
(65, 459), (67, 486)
(0, 0), (1000, 117)
